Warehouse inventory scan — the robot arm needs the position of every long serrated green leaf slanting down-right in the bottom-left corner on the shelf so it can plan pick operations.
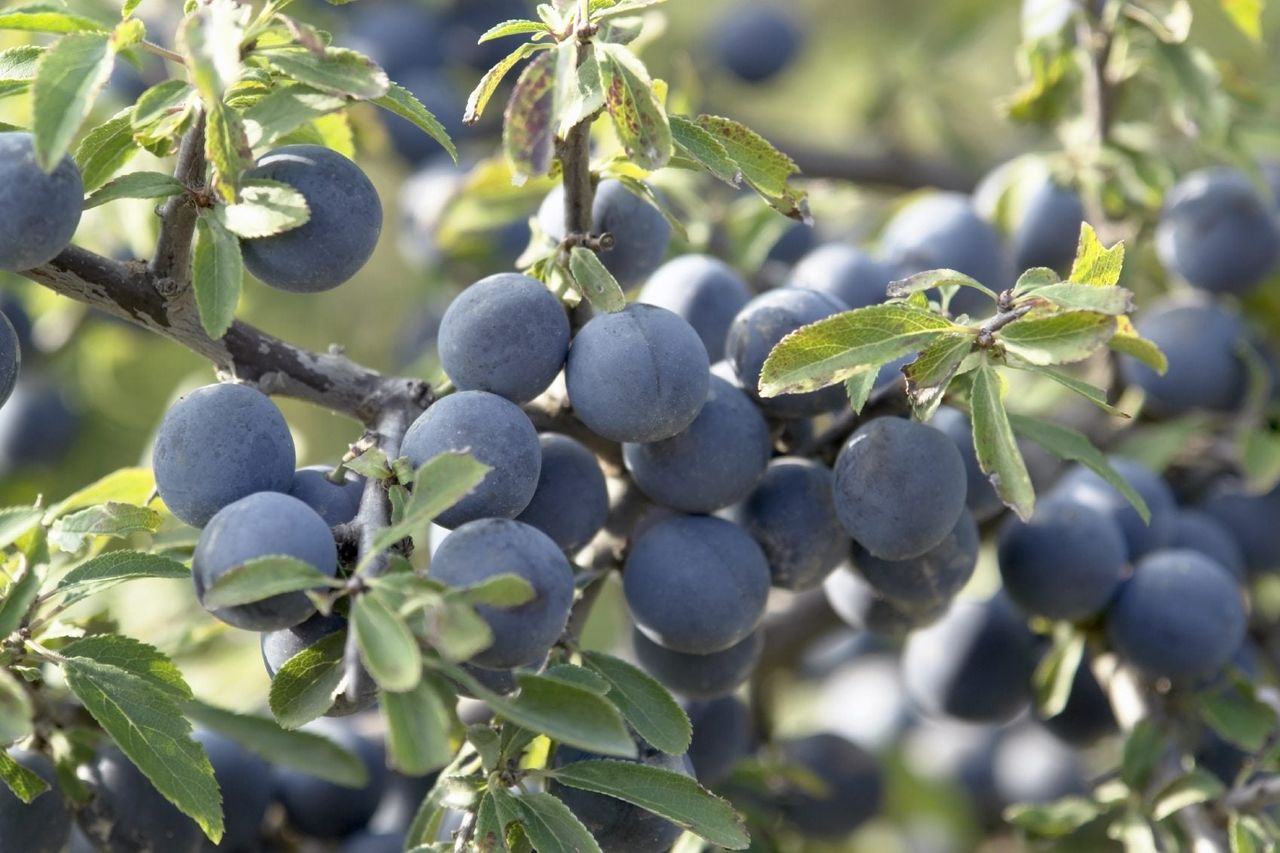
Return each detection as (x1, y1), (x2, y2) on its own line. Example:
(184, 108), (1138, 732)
(63, 657), (223, 843)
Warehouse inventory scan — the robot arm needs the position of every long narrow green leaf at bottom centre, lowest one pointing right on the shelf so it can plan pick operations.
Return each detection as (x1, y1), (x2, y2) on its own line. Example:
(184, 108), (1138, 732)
(549, 761), (749, 850)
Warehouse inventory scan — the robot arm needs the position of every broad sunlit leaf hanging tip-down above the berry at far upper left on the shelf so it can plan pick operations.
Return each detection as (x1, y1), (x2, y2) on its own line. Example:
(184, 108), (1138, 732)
(32, 32), (115, 172)
